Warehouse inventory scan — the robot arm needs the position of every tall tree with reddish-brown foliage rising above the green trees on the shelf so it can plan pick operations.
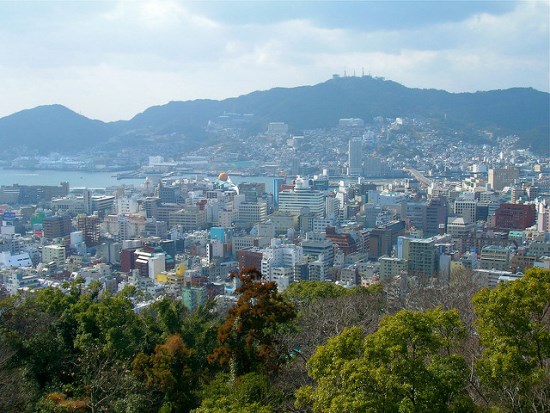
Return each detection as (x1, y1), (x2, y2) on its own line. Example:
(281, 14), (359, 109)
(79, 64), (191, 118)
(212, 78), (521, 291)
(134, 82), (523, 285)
(209, 268), (296, 375)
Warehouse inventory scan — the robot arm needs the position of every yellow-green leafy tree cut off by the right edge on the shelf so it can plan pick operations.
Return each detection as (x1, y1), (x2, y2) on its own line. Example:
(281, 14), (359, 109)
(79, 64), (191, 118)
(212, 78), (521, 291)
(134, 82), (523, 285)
(474, 268), (550, 412)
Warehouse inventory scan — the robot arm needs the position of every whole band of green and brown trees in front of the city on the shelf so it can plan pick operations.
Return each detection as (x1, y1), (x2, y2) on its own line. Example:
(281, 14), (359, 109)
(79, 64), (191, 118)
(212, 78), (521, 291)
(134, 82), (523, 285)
(0, 269), (550, 413)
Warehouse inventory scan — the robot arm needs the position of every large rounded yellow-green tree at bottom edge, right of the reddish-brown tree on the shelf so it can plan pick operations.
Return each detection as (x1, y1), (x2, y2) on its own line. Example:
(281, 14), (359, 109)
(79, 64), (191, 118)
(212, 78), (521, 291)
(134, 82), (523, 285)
(297, 309), (474, 413)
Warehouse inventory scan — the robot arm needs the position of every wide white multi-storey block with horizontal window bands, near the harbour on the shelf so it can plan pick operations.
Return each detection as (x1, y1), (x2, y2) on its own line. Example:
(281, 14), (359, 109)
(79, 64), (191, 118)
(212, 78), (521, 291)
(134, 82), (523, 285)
(279, 178), (325, 218)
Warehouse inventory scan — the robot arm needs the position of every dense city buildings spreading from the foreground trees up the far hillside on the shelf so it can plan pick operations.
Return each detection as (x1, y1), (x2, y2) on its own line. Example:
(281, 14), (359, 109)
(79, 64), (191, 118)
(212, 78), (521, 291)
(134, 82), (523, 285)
(0, 110), (550, 300)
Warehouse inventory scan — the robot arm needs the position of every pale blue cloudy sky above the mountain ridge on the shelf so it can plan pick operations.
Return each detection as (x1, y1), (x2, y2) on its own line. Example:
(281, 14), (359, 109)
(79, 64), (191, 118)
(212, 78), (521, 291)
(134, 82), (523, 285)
(0, 0), (550, 121)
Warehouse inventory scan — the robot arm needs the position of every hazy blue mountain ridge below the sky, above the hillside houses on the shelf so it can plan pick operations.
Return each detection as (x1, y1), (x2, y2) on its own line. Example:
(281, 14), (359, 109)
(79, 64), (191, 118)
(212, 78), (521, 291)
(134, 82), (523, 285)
(0, 76), (550, 154)
